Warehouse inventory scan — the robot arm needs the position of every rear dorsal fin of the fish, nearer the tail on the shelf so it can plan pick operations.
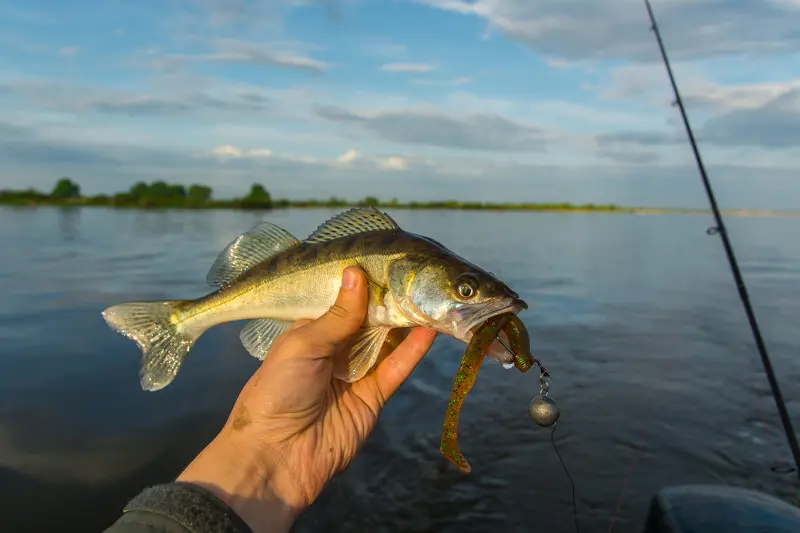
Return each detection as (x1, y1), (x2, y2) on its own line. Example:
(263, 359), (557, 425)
(206, 220), (300, 287)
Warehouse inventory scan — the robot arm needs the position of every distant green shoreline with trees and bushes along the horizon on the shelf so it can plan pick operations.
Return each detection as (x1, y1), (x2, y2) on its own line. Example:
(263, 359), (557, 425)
(0, 178), (800, 217)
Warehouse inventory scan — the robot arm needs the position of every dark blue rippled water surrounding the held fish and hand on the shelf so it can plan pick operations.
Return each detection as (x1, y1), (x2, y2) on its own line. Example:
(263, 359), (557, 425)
(0, 208), (800, 533)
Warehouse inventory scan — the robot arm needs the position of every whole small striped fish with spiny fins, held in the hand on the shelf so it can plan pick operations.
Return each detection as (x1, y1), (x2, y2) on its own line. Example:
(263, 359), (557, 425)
(102, 206), (528, 391)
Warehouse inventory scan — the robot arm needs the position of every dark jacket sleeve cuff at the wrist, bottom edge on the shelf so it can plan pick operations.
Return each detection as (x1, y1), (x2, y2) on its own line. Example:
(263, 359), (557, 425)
(104, 481), (252, 533)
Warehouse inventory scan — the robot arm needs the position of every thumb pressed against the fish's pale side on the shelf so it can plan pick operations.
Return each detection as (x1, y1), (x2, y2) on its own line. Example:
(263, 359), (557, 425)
(297, 267), (367, 346)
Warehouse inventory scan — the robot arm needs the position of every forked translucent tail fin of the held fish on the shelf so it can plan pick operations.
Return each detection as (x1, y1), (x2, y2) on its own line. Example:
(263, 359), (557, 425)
(103, 300), (202, 391)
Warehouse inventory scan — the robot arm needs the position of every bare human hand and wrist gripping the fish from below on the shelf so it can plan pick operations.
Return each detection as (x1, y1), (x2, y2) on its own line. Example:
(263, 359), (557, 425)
(178, 267), (436, 532)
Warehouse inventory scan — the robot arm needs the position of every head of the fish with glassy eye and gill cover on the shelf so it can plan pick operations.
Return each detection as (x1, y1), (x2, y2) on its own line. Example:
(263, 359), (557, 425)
(390, 254), (528, 343)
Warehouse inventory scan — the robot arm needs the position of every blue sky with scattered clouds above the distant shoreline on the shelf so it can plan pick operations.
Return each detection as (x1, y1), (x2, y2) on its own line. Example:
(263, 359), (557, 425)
(0, 0), (800, 209)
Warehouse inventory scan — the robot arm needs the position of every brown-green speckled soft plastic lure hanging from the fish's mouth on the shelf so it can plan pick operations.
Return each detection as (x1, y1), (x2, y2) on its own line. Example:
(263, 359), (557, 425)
(439, 313), (533, 474)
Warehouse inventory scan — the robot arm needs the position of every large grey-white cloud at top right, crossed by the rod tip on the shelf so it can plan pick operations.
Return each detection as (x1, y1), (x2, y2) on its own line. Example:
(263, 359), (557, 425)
(411, 0), (800, 61)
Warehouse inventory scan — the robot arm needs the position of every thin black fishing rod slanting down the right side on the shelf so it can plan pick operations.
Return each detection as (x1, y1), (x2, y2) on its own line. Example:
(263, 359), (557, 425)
(644, 0), (800, 477)
